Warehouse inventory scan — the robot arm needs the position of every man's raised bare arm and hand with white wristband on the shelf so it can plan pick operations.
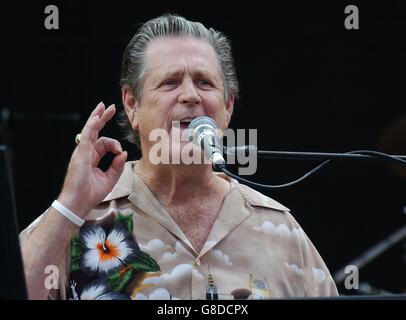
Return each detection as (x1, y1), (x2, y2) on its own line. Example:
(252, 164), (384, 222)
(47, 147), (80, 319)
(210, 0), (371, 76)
(21, 103), (127, 299)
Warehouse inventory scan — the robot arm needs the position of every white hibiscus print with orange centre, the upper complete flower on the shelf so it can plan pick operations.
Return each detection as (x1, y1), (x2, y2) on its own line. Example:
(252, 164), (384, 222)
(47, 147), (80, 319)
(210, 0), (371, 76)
(79, 222), (140, 277)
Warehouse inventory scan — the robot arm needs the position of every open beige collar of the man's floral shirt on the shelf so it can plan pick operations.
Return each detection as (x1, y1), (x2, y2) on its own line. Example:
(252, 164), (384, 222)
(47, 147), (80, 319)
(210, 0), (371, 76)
(104, 161), (289, 258)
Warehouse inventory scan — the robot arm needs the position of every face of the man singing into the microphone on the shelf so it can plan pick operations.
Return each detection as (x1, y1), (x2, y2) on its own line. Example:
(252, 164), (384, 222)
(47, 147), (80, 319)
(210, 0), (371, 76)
(136, 37), (234, 164)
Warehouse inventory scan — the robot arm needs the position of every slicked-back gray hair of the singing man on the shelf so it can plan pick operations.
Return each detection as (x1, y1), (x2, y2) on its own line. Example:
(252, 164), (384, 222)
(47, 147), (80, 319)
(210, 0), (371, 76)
(119, 14), (239, 146)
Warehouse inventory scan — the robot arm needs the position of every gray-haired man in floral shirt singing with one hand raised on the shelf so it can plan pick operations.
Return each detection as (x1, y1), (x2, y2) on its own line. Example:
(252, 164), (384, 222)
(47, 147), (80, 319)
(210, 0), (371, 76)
(20, 15), (337, 300)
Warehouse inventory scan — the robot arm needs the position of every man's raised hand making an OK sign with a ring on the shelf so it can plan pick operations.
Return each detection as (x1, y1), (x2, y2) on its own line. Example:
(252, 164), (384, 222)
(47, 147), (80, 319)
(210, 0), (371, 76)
(58, 102), (127, 218)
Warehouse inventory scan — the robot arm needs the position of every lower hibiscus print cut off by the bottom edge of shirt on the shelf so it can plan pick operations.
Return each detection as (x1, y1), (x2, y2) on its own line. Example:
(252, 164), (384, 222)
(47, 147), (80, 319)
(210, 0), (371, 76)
(70, 279), (131, 300)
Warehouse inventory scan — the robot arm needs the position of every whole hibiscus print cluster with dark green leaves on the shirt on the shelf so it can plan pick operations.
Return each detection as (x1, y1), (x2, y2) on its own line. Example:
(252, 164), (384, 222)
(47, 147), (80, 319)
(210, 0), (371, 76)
(70, 211), (160, 300)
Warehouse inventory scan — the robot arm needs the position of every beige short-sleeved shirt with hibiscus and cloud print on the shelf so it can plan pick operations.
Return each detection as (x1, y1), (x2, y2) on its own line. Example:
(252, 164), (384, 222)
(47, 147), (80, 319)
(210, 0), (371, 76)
(20, 162), (337, 300)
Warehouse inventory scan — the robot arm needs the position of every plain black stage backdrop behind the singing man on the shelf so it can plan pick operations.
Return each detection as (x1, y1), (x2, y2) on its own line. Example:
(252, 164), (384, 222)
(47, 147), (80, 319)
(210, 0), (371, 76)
(0, 1), (406, 294)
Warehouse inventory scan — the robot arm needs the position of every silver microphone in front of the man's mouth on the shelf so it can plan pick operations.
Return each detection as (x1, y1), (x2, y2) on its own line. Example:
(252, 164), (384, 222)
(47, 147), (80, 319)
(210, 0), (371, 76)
(188, 117), (226, 171)
